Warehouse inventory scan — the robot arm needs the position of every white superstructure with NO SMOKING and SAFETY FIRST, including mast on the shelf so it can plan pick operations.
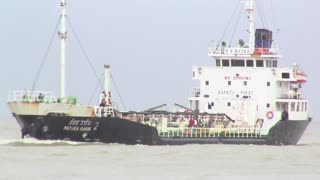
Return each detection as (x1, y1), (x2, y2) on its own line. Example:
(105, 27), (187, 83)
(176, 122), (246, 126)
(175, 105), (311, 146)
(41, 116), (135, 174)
(189, 0), (309, 133)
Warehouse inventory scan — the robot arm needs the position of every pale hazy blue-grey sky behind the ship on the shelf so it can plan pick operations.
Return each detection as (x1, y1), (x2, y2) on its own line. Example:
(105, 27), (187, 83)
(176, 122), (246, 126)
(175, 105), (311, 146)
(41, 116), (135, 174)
(0, 0), (320, 119)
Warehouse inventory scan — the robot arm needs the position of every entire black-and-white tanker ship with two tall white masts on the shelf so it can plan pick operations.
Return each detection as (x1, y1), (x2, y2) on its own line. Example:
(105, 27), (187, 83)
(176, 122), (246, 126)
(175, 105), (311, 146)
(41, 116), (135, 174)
(8, 0), (311, 145)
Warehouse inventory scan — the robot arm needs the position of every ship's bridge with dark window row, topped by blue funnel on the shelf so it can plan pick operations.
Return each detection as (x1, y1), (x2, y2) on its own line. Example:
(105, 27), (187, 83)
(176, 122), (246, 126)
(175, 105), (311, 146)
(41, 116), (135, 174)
(208, 29), (281, 68)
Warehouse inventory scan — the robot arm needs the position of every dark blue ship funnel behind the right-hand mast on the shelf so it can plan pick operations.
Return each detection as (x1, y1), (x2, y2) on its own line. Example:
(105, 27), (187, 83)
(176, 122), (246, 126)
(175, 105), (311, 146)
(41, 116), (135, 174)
(255, 29), (272, 49)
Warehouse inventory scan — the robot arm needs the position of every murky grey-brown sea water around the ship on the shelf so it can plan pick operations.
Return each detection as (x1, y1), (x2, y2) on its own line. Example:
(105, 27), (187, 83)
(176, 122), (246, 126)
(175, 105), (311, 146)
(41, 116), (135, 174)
(0, 118), (320, 180)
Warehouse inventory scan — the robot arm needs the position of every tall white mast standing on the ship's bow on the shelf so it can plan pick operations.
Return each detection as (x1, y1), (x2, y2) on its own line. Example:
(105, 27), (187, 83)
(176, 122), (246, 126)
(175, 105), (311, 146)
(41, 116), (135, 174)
(59, 0), (67, 100)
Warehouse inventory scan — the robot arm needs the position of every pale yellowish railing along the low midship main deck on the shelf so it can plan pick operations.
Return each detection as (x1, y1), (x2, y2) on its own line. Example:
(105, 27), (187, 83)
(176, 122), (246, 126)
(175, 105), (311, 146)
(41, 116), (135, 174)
(158, 128), (263, 139)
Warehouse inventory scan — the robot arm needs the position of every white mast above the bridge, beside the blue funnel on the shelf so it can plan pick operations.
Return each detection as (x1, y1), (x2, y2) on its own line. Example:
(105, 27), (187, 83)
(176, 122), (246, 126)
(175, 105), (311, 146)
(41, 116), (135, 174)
(245, 0), (255, 53)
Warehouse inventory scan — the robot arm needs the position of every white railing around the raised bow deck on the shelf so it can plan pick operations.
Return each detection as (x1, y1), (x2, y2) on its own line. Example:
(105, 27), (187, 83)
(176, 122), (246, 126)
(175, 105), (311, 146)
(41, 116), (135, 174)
(8, 91), (57, 103)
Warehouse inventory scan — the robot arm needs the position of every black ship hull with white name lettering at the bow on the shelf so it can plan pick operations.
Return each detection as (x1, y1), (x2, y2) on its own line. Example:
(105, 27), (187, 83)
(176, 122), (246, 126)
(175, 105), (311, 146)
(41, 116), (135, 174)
(14, 114), (310, 145)
